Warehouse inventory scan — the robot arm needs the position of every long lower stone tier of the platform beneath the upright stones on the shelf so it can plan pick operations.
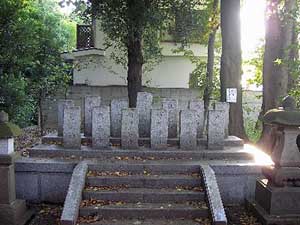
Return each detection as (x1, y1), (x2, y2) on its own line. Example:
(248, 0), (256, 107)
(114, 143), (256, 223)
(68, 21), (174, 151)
(28, 144), (254, 161)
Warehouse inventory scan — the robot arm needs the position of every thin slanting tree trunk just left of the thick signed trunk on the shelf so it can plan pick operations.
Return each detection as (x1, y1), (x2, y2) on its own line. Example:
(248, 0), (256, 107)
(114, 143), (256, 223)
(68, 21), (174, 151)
(203, 0), (219, 124)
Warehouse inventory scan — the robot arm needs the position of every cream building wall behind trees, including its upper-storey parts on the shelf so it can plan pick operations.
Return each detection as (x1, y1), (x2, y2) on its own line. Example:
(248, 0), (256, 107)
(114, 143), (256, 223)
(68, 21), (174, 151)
(72, 19), (206, 88)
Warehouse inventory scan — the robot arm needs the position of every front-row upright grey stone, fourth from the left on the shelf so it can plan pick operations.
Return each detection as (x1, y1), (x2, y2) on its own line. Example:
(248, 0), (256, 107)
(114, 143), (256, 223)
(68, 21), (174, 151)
(151, 109), (168, 149)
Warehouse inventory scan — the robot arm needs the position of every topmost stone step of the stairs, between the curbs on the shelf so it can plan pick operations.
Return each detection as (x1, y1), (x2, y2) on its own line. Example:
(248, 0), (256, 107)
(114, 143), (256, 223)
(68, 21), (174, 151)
(89, 161), (200, 175)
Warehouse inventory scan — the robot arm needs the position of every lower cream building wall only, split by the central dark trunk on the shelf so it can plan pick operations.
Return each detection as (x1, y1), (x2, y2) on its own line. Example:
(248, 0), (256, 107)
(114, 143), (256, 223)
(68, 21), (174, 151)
(73, 55), (202, 88)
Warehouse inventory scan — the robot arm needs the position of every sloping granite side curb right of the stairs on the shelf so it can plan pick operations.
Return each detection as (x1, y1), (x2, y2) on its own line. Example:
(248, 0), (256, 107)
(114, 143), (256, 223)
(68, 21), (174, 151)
(201, 165), (227, 225)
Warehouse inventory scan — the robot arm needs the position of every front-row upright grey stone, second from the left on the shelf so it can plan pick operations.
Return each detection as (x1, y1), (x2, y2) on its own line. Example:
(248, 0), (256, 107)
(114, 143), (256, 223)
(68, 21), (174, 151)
(92, 106), (110, 149)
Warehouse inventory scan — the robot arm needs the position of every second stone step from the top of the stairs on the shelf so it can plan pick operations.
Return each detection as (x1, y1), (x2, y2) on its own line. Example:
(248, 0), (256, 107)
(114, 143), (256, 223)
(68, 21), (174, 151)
(86, 174), (201, 188)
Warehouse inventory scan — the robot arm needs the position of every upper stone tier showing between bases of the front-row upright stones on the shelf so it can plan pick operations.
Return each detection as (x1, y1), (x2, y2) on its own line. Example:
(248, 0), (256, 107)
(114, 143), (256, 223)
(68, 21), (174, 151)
(42, 133), (244, 149)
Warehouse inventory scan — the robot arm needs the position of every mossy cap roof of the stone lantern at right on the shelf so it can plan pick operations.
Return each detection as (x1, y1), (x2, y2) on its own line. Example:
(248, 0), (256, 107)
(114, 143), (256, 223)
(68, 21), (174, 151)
(263, 109), (300, 126)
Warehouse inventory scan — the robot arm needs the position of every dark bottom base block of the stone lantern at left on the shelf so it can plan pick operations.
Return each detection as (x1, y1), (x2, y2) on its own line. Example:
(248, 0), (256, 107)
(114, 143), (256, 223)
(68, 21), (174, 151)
(0, 200), (33, 225)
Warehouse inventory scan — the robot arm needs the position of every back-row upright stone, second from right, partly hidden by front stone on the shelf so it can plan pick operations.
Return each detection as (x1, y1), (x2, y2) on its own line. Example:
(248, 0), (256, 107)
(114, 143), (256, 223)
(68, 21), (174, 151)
(189, 100), (204, 138)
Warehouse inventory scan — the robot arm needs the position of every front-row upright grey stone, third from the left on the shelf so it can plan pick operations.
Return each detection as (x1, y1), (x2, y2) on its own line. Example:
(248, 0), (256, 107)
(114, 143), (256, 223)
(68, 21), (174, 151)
(121, 108), (139, 149)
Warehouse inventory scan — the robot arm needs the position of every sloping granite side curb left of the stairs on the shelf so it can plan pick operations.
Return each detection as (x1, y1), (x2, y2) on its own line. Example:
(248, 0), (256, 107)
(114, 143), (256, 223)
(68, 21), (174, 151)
(60, 161), (88, 225)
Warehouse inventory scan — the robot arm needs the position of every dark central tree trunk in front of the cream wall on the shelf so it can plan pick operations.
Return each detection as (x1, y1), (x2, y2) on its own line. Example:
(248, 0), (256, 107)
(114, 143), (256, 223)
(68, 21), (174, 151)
(127, 35), (143, 108)
